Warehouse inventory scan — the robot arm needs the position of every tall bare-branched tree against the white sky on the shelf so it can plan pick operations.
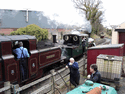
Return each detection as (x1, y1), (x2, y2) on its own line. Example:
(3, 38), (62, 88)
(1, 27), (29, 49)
(72, 0), (103, 34)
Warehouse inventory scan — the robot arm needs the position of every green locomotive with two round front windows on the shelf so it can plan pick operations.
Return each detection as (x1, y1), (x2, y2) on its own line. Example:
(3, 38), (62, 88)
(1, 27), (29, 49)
(63, 34), (88, 59)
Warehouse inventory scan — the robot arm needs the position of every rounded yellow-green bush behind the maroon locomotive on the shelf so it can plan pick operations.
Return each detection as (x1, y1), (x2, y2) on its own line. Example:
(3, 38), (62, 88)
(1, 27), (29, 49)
(10, 24), (48, 41)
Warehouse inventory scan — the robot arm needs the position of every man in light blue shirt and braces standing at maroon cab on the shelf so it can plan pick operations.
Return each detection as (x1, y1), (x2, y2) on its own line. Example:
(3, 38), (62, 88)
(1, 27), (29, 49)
(13, 42), (29, 81)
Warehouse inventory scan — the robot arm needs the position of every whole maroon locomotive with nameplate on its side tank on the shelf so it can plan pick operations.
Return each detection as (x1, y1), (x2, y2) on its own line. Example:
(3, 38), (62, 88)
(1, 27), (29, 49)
(0, 35), (65, 87)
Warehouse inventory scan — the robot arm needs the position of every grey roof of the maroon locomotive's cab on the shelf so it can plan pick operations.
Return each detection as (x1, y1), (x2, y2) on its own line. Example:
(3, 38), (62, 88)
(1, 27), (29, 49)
(0, 35), (36, 41)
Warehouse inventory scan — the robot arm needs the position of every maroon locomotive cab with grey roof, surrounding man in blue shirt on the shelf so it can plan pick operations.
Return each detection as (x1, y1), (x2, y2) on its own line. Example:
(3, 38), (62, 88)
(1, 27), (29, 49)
(0, 35), (38, 83)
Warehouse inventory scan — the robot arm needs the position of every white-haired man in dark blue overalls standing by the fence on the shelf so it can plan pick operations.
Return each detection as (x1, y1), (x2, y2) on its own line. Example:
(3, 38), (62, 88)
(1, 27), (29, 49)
(66, 58), (80, 87)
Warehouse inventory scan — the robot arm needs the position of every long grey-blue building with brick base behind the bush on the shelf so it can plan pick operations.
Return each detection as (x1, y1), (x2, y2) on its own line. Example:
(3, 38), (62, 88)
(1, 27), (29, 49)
(0, 9), (71, 34)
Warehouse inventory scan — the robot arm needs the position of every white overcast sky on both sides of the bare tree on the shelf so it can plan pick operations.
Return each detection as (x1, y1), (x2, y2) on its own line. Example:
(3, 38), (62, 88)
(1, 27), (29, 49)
(0, 0), (125, 26)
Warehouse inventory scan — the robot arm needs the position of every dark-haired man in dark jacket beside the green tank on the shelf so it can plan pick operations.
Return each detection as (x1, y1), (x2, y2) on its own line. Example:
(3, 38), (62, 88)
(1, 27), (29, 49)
(87, 64), (101, 83)
